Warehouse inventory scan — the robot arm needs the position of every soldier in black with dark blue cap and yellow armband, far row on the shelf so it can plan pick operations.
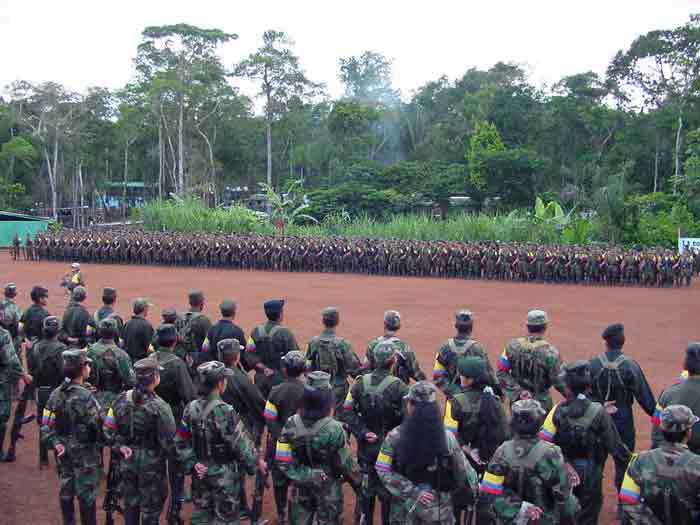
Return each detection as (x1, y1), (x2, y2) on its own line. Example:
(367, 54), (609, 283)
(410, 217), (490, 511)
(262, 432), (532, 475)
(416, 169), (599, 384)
(246, 299), (299, 396)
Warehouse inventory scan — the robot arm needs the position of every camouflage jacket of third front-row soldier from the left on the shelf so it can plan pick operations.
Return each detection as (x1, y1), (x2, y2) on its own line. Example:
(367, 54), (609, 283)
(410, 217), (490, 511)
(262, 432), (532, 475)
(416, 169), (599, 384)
(175, 393), (258, 477)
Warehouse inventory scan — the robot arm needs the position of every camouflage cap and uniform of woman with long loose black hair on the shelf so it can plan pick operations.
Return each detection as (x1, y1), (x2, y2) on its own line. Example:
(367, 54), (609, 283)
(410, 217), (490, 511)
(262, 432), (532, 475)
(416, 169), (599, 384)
(375, 381), (477, 525)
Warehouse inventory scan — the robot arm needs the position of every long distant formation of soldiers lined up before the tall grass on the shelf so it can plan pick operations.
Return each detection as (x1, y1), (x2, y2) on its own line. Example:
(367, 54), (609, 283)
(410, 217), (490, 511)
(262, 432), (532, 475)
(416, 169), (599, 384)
(16, 229), (700, 287)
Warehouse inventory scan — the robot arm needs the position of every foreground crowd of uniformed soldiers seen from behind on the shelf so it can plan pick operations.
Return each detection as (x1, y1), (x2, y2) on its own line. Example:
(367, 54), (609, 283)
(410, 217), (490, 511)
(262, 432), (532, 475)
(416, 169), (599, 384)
(0, 276), (700, 525)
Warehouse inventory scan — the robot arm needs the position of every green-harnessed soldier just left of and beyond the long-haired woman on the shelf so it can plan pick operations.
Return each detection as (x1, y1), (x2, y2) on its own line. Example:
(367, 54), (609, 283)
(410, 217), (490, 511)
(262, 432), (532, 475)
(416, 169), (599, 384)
(340, 341), (408, 525)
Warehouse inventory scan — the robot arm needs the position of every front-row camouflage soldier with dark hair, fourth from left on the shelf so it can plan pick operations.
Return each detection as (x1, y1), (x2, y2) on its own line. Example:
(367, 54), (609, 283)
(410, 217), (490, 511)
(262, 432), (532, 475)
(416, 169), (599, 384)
(275, 371), (358, 525)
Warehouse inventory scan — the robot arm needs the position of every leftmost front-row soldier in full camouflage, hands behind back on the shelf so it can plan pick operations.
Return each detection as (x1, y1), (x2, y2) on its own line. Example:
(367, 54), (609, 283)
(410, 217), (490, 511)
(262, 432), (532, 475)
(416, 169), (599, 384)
(41, 349), (102, 525)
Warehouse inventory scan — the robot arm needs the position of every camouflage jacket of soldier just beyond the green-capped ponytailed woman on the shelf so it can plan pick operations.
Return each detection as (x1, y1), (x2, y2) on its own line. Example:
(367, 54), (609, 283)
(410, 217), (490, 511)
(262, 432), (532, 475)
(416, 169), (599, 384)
(433, 337), (496, 394)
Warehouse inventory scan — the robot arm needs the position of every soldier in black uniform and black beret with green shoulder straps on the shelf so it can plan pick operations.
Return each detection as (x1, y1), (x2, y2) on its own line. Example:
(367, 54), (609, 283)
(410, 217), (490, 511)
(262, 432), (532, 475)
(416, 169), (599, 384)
(591, 324), (656, 491)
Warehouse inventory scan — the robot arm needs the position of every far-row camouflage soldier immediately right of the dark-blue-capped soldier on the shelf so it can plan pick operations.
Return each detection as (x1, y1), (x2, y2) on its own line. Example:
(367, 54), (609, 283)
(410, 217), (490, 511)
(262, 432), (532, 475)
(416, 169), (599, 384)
(306, 306), (362, 413)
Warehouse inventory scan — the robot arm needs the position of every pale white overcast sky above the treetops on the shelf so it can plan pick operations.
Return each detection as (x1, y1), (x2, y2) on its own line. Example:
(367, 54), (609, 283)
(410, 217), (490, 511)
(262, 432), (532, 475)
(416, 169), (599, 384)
(0, 0), (700, 104)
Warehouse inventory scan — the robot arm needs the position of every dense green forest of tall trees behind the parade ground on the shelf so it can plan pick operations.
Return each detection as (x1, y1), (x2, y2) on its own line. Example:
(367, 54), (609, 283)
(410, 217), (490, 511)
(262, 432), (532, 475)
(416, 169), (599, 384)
(0, 16), (700, 244)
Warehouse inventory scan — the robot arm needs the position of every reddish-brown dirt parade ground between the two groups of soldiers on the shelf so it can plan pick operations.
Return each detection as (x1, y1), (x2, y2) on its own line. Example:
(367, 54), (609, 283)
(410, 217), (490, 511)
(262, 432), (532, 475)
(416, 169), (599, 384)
(0, 253), (700, 525)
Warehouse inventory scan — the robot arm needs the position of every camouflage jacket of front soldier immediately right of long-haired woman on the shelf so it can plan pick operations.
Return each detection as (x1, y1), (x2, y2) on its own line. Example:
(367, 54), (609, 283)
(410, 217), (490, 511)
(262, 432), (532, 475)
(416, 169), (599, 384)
(479, 437), (578, 525)
